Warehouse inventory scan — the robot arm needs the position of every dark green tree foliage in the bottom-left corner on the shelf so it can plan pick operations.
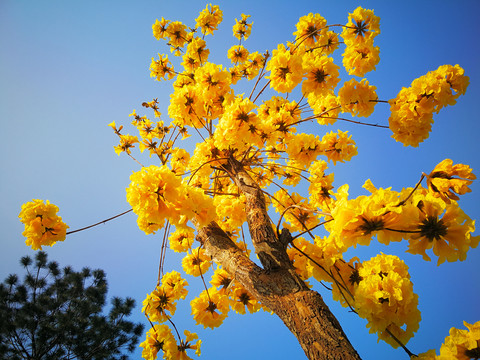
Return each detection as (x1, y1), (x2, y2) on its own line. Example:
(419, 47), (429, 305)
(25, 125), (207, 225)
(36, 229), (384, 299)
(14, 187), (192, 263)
(0, 252), (143, 360)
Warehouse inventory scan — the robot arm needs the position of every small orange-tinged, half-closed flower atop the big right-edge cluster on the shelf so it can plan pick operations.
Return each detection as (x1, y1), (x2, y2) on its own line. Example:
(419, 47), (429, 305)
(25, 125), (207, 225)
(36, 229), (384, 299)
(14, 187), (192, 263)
(427, 159), (477, 203)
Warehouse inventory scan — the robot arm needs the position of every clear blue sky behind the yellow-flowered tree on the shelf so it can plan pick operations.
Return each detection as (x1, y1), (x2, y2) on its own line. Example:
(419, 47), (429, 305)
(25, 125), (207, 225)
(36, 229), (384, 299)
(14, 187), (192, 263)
(0, 0), (480, 359)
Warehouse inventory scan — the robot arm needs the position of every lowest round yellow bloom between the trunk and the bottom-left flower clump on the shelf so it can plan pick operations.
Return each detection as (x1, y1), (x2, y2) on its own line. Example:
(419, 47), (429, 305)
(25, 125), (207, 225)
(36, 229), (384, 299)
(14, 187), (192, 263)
(190, 287), (229, 329)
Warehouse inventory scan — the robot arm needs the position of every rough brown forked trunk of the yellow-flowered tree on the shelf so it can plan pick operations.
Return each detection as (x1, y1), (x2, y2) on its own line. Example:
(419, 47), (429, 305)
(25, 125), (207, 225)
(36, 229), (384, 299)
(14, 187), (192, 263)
(197, 158), (360, 360)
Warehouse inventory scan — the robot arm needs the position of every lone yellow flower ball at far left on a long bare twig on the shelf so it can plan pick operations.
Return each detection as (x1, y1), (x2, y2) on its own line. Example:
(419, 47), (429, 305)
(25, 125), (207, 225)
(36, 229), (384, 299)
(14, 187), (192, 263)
(18, 199), (68, 250)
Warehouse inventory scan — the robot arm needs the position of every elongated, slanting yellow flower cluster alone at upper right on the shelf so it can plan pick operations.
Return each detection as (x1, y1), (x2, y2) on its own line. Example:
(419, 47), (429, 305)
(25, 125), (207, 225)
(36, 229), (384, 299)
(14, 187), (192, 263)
(388, 65), (469, 146)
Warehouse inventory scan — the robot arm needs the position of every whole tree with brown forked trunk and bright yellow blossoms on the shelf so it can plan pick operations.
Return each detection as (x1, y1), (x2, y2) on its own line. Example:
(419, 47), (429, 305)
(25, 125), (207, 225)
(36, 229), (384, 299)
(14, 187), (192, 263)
(16, 5), (480, 359)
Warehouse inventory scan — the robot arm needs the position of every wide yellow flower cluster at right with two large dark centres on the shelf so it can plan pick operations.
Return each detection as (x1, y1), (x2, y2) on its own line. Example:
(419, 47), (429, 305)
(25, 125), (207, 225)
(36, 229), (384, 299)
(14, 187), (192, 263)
(325, 164), (480, 264)
